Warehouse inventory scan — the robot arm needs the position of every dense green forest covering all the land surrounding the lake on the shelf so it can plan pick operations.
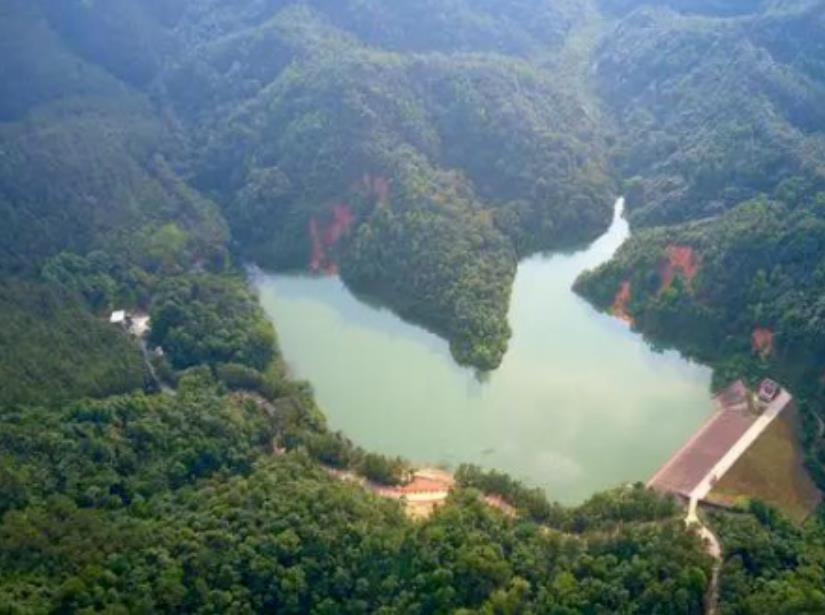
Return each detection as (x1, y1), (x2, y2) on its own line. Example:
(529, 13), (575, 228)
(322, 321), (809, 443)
(0, 0), (825, 614)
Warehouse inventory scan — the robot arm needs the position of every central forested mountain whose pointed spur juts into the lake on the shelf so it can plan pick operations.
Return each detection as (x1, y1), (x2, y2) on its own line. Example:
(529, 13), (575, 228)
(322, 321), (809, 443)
(161, 3), (609, 368)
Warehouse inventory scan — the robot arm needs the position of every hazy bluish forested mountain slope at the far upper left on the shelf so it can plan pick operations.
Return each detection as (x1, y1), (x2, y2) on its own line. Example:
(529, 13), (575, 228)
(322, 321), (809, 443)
(0, 0), (225, 272)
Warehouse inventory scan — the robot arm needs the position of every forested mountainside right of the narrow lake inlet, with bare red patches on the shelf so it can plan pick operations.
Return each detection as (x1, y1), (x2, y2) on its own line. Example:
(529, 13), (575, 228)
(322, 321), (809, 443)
(578, 2), (825, 482)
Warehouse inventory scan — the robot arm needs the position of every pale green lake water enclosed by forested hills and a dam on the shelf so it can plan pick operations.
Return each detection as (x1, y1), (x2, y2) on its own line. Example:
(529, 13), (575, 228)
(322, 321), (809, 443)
(253, 201), (711, 503)
